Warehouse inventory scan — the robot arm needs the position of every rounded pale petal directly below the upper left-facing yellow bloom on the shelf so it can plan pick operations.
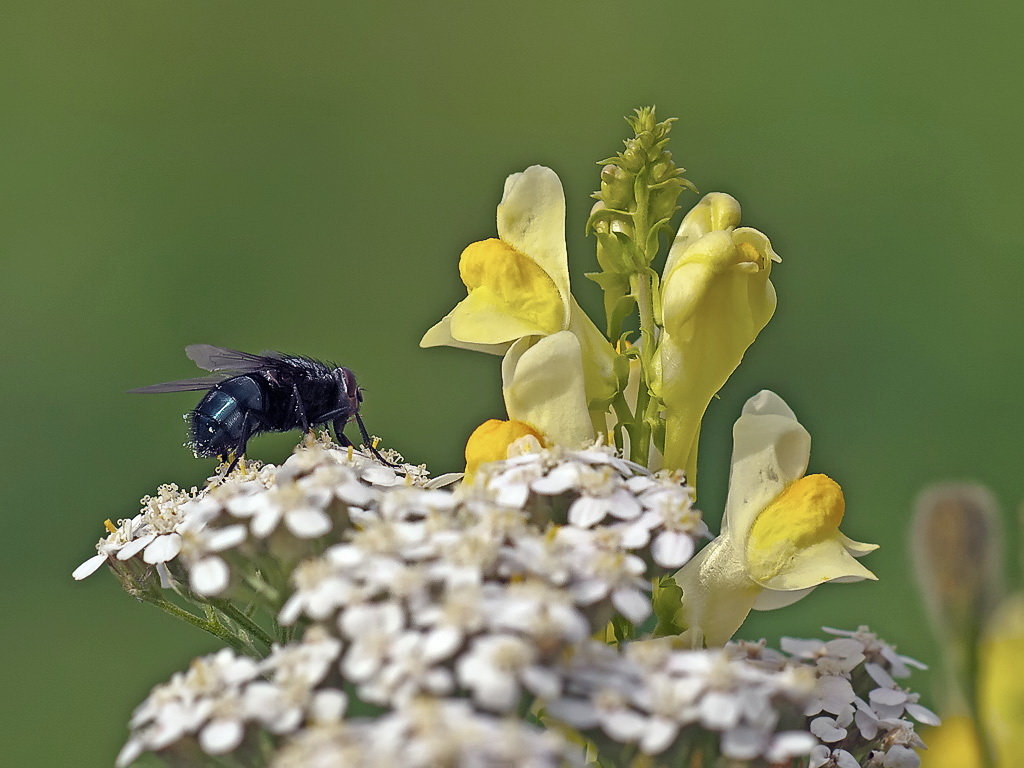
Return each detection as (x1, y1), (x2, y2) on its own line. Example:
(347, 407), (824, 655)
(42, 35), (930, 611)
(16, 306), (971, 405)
(502, 331), (594, 447)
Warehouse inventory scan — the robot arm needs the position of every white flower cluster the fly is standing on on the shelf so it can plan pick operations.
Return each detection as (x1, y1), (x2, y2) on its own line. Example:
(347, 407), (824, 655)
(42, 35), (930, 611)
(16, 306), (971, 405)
(73, 433), (436, 597)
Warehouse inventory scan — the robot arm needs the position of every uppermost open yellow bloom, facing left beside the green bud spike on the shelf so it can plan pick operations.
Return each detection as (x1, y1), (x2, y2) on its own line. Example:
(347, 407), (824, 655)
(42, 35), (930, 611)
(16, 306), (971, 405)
(420, 166), (617, 428)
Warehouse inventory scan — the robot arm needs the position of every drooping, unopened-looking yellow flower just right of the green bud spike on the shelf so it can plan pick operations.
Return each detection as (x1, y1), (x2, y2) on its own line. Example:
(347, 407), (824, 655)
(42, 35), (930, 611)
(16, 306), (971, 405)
(653, 193), (781, 482)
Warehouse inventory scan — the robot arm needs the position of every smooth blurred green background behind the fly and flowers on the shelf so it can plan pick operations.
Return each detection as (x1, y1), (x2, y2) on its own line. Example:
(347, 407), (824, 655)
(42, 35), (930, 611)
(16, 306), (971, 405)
(0, 0), (1024, 767)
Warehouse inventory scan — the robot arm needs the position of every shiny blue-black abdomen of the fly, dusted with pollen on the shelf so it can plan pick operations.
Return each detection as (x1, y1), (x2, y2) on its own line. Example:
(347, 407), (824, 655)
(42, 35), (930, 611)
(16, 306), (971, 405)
(189, 376), (263, 456)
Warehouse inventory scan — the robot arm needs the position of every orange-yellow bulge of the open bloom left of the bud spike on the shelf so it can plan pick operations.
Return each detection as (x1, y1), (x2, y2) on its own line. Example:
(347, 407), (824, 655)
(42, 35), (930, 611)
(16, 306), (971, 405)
(459, 238), (564, 334)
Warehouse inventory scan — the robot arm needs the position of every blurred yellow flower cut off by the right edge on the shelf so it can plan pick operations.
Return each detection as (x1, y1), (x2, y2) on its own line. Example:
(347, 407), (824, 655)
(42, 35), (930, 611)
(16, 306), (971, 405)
(974, 593), (1024, 768)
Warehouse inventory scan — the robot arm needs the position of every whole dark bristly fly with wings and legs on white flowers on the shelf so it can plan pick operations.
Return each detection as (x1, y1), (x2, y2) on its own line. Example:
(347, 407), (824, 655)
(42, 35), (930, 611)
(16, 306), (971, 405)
(130, 344), (390, 474)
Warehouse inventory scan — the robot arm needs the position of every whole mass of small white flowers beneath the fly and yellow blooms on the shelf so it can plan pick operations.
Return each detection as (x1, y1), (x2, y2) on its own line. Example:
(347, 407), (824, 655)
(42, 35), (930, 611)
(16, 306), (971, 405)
(81, 438), (934, 768)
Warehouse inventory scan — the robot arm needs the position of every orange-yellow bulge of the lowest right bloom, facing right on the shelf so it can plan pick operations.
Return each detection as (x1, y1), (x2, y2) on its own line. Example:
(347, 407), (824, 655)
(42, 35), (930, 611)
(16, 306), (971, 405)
(746, 475), (846, 582)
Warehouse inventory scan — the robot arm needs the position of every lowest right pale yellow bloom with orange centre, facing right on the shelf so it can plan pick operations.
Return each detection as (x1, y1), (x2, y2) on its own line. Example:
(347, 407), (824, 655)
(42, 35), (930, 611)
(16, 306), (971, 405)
(673, 390), (877, 645)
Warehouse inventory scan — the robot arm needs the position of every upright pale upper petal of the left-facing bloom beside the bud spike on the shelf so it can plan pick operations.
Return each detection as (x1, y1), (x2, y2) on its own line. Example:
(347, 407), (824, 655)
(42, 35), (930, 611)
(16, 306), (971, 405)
(498, 165), (569, 329)
